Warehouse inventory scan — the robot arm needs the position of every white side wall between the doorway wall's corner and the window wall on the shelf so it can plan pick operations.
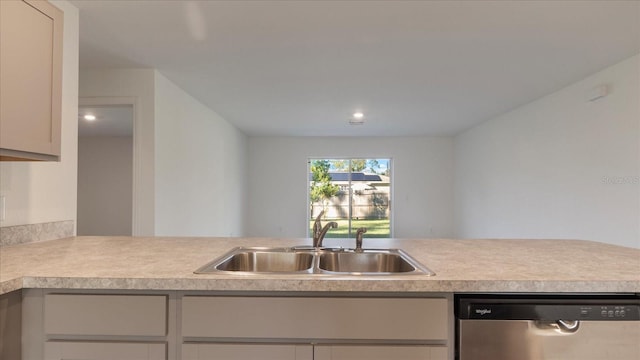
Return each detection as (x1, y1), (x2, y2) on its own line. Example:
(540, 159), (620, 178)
(155, 72), (247, 236)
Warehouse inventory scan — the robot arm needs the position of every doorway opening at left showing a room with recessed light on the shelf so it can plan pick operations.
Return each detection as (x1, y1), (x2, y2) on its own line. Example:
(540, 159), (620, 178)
(77, 105), (134, 236)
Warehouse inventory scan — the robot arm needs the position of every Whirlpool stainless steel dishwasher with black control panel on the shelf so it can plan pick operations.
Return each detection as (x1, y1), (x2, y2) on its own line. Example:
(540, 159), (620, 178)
(455, 294), (640, 360)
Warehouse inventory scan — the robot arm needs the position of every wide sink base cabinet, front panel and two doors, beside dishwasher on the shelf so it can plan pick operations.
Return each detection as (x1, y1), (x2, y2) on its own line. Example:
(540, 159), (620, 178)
(181, 295), (451, 360)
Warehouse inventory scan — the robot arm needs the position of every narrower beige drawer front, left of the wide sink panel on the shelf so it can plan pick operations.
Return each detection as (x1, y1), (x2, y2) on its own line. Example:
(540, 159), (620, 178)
(44, 294), (167, 336)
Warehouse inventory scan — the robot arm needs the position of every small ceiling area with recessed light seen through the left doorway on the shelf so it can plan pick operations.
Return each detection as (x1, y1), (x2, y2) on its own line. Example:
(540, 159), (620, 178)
(78, 105), (133, 137)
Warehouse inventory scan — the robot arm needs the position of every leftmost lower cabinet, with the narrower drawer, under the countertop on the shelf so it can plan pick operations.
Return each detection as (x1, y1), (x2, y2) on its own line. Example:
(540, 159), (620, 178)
(23, 292), (176, 360)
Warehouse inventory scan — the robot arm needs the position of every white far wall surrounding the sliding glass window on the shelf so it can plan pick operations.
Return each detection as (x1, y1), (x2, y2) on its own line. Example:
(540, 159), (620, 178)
(247, 137), (453, 238)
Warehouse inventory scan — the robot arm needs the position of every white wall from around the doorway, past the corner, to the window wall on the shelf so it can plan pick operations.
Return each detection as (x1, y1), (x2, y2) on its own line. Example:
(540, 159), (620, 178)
(80, 69), (247, 236)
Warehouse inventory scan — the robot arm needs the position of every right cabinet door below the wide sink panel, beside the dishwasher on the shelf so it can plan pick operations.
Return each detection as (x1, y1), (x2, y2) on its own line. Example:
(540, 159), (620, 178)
(313, 345), (447, 360)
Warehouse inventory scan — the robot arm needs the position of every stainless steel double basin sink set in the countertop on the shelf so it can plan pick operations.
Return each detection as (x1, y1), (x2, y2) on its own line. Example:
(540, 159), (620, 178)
(195, 247), (435, 276)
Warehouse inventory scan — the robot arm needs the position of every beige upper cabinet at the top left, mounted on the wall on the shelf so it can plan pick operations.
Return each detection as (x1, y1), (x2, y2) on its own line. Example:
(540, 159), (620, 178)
(0, 0), (63, 161)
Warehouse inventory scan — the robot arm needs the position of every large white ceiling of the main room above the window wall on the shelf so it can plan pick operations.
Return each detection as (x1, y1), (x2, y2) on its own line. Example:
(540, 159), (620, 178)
(71, 0), (640, 136)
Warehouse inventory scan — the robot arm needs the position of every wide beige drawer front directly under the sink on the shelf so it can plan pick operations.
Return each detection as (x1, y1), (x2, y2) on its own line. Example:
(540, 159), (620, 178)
(182, 296), (448, 340)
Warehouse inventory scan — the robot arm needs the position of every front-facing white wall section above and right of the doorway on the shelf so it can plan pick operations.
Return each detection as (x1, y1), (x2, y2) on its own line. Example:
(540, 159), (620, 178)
(76, 69), (155, 236)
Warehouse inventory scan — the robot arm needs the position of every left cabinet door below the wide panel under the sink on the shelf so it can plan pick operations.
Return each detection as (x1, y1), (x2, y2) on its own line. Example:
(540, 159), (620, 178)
(182, 344), (313, 360)
